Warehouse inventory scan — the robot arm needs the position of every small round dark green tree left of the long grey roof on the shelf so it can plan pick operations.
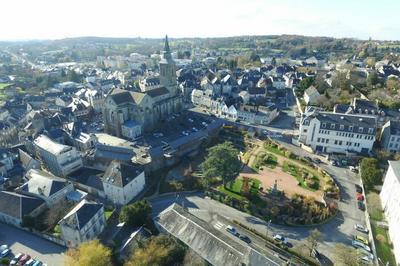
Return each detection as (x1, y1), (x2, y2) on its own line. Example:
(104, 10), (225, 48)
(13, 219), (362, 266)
(119, 200), (151, 227)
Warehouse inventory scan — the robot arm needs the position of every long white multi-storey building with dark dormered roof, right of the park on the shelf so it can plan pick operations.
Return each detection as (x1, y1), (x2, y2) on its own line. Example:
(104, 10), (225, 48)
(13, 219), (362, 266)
(299, 111), (376, 154)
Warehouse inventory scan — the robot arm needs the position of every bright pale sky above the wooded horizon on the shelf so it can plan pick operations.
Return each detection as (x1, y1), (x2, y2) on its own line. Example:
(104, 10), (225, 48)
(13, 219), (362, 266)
(0, 0), (400, 40)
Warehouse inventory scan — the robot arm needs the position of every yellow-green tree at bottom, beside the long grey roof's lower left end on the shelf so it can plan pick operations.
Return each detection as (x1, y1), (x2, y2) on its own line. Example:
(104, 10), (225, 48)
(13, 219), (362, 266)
(125, 235), (185, 266)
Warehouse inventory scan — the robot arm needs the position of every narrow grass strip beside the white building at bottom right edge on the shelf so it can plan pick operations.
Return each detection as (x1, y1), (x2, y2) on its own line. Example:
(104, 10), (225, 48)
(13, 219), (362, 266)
(371, 223), (396, 265)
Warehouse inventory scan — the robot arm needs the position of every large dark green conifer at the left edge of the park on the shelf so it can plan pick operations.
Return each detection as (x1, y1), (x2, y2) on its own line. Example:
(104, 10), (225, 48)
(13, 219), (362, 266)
(201, 142), (242, 188)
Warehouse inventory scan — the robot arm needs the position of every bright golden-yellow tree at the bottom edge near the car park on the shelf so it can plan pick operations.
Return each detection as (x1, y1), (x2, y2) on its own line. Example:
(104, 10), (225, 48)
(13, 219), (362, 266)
(65, 239), (112, 266)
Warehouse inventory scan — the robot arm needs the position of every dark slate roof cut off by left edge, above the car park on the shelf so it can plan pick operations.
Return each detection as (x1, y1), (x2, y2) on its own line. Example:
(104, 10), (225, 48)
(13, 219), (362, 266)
(0, 191), (44, 219)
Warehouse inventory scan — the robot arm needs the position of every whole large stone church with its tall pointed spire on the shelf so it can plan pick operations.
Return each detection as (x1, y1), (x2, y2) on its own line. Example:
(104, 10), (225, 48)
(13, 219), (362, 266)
(103, 36), (183, 138)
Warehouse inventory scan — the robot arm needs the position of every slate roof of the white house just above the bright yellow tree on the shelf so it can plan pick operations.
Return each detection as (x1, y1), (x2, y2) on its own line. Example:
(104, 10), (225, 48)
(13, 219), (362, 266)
(60, 199), (103, 229)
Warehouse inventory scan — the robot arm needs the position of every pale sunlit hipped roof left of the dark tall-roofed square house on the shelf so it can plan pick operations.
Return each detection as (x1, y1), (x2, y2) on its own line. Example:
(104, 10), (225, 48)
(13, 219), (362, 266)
(20, 169), (68, 197)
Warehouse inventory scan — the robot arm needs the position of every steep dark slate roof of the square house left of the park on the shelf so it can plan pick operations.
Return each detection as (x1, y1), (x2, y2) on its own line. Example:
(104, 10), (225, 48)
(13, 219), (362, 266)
(102, 161), (143, 187)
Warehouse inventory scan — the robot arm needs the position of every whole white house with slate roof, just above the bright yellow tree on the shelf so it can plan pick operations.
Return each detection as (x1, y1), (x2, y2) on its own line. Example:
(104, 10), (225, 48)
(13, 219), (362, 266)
(58, 200), (106, 247)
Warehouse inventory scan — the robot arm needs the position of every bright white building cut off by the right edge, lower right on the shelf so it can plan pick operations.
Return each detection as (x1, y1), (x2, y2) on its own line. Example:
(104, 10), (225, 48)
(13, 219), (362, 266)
(380, 161), (400, 263)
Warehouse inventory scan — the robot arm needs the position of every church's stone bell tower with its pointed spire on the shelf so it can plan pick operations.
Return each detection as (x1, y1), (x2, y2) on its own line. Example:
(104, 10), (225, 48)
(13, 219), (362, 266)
(160, 35), (177, 94)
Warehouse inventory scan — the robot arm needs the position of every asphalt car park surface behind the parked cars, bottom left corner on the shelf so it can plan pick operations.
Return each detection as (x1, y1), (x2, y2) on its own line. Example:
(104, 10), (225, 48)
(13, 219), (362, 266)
(0, 223), (65, 266)
